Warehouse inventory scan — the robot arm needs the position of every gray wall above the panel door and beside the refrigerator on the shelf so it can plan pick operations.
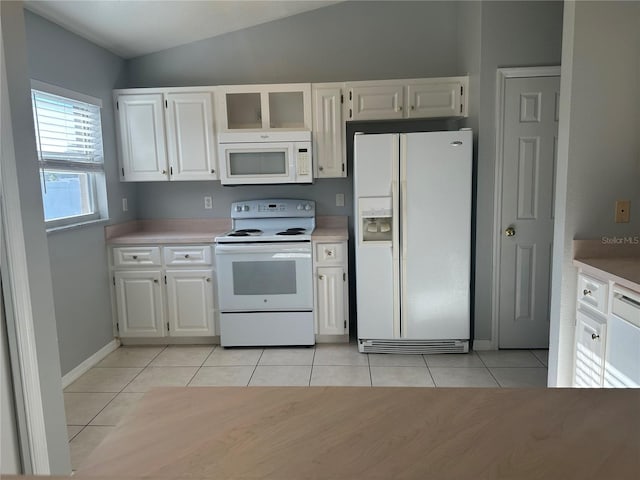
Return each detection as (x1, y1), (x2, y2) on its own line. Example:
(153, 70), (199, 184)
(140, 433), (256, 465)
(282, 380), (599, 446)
(475, 2), (562, 339)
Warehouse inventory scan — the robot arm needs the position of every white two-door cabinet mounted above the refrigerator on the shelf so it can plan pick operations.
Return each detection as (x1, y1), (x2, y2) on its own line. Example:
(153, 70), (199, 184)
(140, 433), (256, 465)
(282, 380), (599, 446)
(347, 77), (469, 120)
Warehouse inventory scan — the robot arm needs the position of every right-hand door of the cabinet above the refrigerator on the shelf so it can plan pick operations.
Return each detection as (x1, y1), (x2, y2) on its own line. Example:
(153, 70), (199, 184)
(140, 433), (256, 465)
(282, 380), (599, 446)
(407, 81), (464, 118)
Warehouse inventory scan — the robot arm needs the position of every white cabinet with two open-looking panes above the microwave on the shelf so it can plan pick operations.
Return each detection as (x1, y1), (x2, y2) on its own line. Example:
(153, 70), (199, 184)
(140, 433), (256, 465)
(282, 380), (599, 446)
(218, 83), (311, 132)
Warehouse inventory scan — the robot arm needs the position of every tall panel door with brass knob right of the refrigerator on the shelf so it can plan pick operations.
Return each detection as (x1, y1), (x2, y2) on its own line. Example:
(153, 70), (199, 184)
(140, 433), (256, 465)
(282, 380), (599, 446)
(498, 76), (560, 348)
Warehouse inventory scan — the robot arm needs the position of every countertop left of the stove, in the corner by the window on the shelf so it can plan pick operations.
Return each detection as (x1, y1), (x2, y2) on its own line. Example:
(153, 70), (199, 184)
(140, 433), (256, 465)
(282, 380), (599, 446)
(105, 218), (231, 245)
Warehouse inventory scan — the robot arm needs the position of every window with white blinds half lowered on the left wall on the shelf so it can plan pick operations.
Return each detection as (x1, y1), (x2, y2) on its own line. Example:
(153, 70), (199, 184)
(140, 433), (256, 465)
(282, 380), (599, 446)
(31, 82), (107, 228)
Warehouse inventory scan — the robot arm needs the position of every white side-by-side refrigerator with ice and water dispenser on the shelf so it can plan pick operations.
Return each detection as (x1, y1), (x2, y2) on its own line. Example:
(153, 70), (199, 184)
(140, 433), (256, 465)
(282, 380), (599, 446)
(354, 130), (473, 354)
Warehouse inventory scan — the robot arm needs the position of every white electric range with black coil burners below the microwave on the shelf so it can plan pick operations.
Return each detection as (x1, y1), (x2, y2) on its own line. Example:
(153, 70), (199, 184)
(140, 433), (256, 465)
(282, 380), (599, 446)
(215, 199), (315, 347)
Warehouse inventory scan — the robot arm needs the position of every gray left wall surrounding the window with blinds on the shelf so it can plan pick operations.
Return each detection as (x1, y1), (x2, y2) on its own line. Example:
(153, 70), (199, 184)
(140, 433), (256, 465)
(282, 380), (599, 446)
(25, 11), (136, 374)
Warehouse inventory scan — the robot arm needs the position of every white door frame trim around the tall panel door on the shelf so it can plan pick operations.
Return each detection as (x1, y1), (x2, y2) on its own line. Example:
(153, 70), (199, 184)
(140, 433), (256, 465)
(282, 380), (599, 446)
(490, 65), (560, 350)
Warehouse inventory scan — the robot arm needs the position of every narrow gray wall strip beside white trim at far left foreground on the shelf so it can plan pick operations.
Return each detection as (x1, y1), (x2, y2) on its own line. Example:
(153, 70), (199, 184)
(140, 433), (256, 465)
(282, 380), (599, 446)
(0, 2), (71, 475)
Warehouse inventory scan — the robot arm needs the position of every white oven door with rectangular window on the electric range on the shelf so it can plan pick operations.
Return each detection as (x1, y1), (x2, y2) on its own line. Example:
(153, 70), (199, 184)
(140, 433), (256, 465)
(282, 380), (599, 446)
(215, 242), (313, 313)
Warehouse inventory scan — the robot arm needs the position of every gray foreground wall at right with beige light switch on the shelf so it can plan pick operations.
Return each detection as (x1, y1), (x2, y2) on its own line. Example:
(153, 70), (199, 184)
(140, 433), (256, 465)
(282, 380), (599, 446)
(549, 2), (640, 386)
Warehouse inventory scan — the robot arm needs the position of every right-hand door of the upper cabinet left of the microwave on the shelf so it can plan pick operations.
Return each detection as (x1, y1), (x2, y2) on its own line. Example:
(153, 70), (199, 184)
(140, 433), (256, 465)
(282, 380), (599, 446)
(166, 92), (218, 180)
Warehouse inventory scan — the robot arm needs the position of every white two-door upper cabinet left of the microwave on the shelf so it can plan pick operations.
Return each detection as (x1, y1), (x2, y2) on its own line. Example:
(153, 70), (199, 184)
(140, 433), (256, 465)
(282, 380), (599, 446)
(115, 89), (218, 182)
